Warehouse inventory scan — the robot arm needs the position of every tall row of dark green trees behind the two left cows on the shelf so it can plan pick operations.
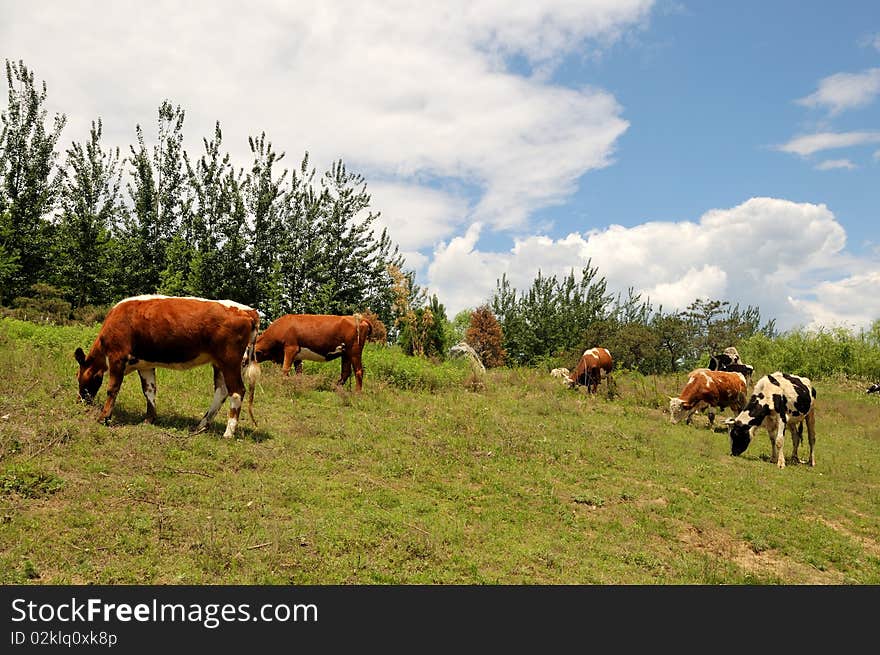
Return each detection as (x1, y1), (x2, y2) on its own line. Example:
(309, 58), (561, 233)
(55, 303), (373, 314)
(0, 61), (412, 326)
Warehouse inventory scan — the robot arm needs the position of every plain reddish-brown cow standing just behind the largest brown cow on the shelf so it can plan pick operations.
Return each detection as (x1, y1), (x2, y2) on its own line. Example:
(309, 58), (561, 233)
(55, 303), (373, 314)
(255, 314), (373, 391)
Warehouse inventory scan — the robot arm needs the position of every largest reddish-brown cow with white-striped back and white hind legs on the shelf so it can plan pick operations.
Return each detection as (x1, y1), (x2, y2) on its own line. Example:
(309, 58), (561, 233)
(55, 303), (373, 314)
(73, 295), (260, 437)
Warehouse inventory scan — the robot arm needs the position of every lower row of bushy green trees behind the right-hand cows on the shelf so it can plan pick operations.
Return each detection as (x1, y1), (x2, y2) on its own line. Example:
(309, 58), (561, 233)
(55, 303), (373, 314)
(491, 262), (776, 373)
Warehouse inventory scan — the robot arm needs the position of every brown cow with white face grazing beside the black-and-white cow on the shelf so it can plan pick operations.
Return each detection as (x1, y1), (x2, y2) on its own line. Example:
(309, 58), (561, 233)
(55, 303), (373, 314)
(669, 368), (746, 429)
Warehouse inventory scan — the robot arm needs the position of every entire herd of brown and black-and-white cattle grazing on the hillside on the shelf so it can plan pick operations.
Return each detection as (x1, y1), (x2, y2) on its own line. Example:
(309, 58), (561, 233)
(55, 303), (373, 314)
(74, 295), (880, 468)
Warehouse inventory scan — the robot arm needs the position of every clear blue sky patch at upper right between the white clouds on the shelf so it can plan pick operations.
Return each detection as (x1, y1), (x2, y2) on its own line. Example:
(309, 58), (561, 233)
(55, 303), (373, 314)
(548, 1), (880, 248)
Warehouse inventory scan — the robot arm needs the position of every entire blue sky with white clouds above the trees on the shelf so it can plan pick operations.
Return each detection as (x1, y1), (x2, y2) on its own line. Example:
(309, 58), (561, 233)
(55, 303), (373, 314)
(0, 0), (880, 330)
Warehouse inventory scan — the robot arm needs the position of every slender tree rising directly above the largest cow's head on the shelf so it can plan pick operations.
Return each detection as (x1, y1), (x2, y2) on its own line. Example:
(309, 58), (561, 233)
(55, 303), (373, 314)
(53, 118), (123, 308)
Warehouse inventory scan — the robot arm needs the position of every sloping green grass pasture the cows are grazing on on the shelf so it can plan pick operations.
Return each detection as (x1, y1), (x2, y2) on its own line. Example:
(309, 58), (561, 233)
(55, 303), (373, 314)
(0, 320), (880, 585)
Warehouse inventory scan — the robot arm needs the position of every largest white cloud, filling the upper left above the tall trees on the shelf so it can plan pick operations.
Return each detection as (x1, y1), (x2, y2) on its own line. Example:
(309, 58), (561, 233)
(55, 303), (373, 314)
(0, 0), (653, 240)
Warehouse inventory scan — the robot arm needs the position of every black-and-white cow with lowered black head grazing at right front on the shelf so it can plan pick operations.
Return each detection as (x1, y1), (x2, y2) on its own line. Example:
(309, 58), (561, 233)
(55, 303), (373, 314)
(726, 371), (816, 468)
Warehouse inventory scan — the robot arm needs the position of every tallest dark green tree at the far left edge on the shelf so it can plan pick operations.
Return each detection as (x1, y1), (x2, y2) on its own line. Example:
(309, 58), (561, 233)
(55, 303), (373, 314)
(0, 59), (67, 304)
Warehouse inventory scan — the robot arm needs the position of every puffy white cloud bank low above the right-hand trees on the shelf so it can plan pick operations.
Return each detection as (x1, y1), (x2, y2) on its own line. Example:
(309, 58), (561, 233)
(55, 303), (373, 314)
(428, 198), (880, 328)
